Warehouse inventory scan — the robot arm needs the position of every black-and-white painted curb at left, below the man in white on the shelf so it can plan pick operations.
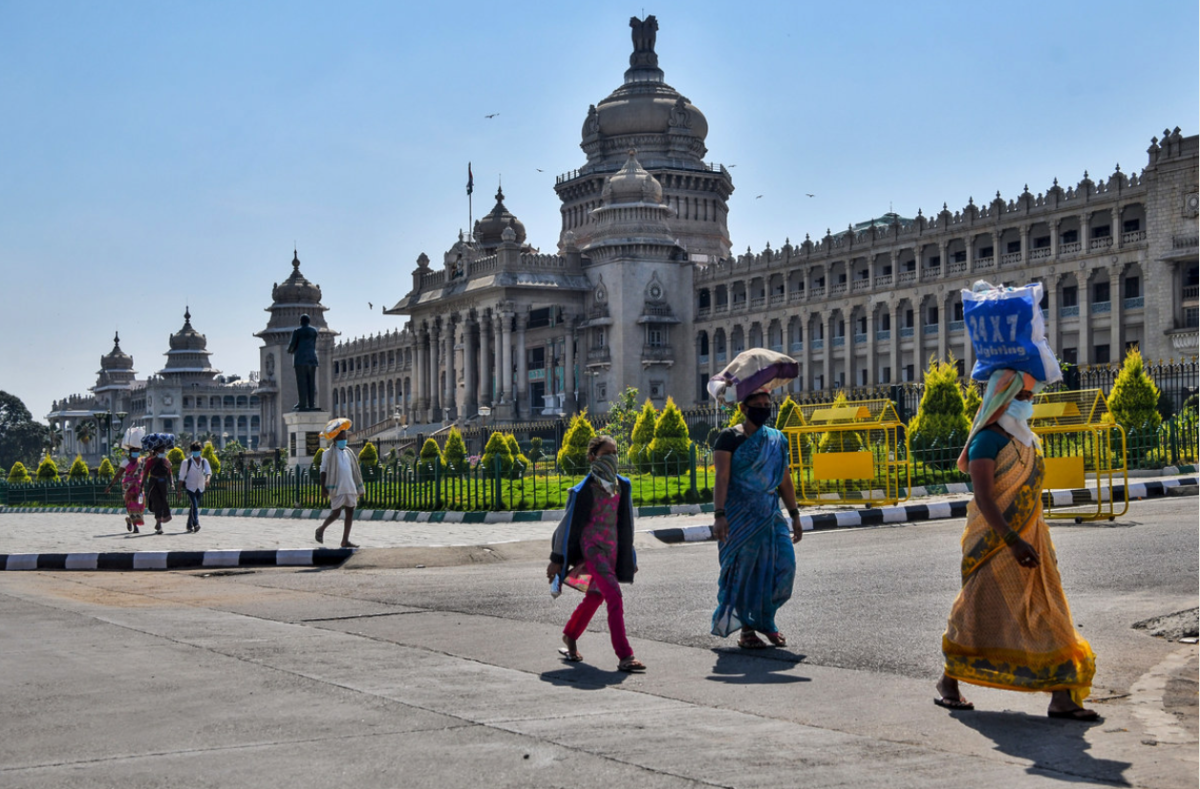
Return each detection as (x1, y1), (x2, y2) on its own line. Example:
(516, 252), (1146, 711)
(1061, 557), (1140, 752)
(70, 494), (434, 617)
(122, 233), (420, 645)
(0, 548), (354, 570)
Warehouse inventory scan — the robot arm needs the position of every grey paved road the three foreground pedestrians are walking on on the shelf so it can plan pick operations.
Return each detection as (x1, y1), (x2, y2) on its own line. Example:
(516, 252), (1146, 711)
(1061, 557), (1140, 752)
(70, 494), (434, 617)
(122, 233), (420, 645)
(0, 499), (1200, 789)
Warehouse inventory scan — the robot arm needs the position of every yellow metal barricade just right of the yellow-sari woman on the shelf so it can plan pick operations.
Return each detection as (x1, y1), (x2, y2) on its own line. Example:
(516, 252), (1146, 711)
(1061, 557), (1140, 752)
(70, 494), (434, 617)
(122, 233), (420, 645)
(1031, 389), (1129, 523)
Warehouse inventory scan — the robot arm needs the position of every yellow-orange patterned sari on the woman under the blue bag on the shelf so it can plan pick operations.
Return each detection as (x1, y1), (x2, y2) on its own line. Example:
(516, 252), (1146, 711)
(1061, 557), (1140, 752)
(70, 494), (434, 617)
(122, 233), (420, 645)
(942, 441), (1096, 704)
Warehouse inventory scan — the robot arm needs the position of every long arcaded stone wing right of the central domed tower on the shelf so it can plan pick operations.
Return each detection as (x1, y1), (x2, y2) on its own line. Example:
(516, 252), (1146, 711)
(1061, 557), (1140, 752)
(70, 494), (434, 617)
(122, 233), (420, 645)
(694, 128), (1198, 398)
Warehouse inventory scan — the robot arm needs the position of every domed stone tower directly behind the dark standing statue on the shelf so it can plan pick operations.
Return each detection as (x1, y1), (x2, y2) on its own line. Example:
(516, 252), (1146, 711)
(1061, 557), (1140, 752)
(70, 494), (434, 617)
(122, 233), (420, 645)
(254, 251), (337, 450)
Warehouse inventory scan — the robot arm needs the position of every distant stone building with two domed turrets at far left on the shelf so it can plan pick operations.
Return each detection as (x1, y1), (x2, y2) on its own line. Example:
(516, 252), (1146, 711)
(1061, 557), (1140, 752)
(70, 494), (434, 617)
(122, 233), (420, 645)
(46, 311), (259, 465)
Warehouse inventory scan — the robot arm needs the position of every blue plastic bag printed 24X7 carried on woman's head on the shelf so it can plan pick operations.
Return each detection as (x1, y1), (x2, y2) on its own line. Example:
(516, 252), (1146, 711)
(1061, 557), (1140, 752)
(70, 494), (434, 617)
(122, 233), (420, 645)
(962, 282), (1062, 384)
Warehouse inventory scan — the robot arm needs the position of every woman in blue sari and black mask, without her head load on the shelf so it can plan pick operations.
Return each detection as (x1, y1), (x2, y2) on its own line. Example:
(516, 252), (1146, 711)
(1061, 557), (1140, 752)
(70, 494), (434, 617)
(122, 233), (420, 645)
(713, 390), (803, 649)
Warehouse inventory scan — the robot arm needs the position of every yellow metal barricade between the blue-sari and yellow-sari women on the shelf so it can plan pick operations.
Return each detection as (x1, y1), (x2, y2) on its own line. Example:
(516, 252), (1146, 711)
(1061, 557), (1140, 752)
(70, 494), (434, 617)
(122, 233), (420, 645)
(784, 399), (911, 505)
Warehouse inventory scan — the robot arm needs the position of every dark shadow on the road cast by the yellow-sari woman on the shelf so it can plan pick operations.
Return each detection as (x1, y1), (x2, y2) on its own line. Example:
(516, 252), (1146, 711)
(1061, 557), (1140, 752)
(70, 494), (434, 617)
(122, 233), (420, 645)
(950, 710), (1130, 787)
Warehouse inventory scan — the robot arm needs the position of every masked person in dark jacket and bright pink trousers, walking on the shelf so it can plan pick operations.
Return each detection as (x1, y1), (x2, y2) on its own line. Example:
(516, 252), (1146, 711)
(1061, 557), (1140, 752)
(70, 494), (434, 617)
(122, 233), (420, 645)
(546, 435), (646, 671)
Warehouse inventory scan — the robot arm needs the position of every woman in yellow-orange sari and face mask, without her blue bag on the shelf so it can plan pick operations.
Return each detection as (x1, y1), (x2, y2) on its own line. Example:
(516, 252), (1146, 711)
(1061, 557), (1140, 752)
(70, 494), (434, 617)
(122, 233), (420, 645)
(934, 369), (1099, 721)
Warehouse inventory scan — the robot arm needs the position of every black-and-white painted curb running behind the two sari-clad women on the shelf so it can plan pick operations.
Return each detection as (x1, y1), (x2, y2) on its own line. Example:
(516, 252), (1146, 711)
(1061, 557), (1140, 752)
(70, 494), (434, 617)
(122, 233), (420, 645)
(649, 477), (1198, 543)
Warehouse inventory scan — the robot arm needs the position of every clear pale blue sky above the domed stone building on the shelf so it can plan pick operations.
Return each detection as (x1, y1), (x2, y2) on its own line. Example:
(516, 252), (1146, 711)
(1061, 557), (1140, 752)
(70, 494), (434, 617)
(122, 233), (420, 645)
(0, 0), (1200, 418)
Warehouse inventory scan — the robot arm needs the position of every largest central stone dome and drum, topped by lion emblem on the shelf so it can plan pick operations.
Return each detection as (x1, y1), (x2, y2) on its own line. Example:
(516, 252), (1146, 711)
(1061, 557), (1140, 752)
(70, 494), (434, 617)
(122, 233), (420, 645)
(554, 16), (733, 265)
